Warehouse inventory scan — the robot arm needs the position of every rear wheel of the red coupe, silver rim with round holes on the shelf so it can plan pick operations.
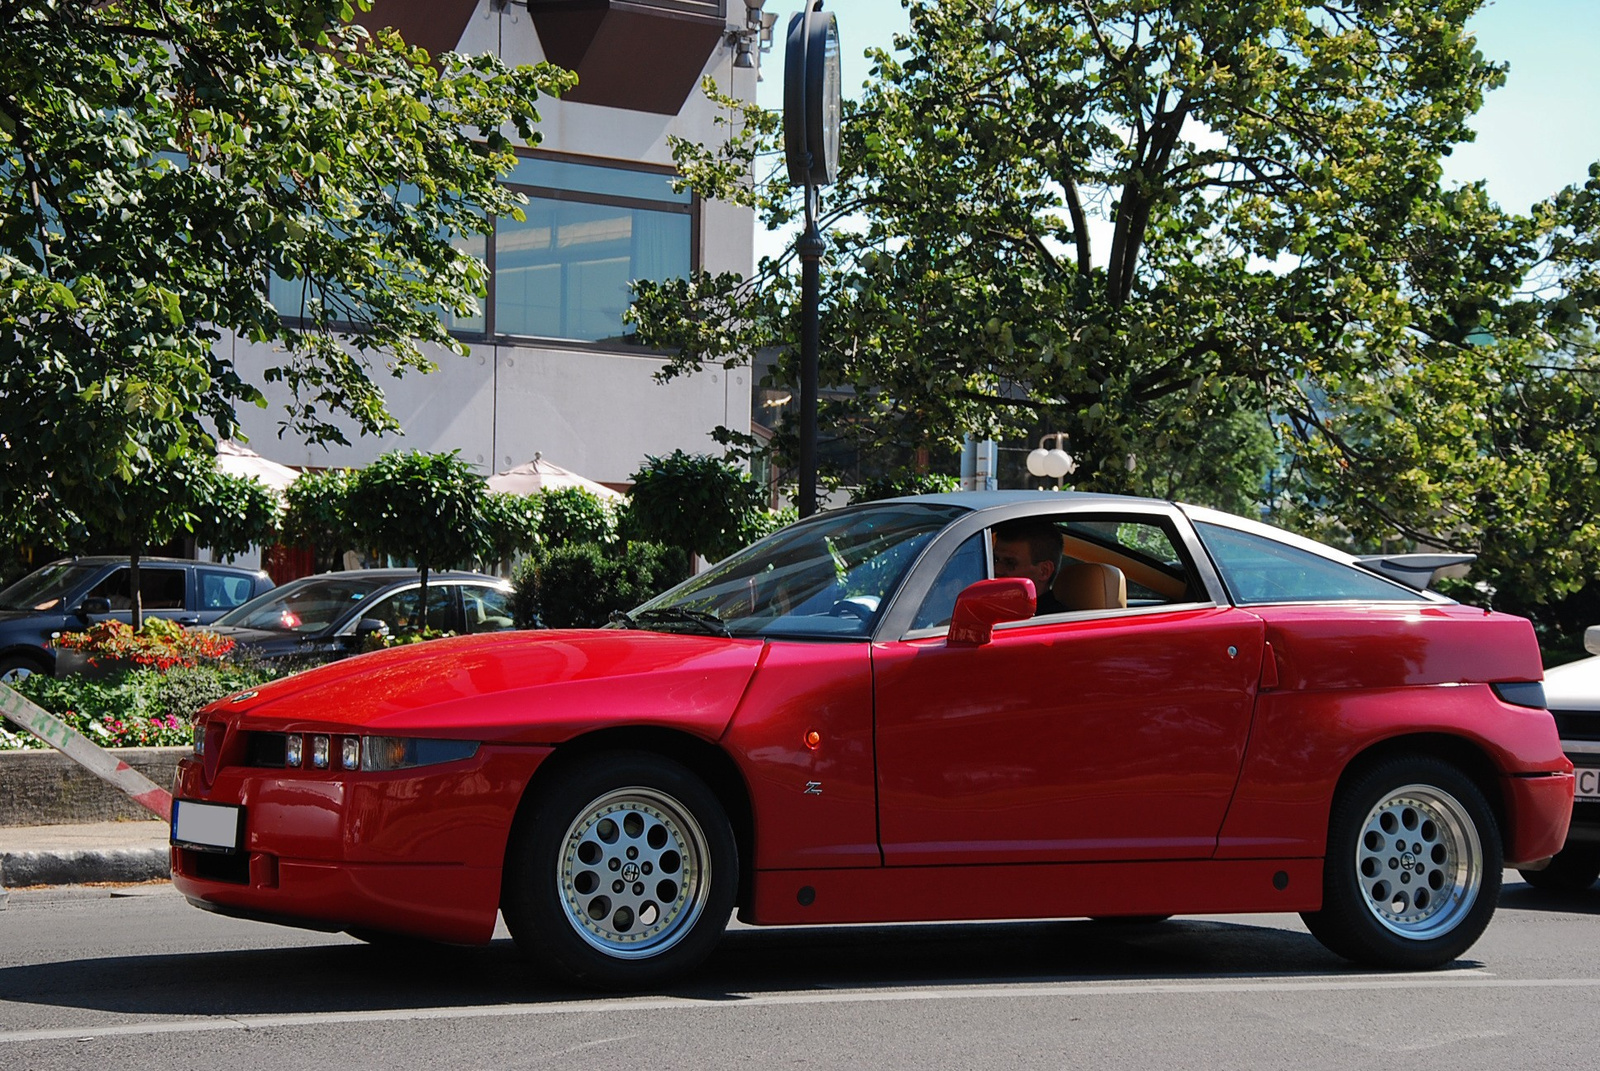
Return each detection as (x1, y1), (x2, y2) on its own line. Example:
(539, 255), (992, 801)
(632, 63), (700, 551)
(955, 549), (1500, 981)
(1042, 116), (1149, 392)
(1301, 757), (1504, 970)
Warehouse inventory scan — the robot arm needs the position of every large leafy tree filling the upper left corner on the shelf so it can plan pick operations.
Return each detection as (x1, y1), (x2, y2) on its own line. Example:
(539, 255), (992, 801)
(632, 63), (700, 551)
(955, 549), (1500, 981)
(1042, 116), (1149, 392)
(0, 0), (570, 579)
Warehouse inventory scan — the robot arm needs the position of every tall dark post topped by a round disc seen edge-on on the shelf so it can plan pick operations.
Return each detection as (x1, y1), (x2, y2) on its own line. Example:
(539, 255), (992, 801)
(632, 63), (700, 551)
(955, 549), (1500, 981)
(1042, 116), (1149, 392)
(784, 0), (840, 517)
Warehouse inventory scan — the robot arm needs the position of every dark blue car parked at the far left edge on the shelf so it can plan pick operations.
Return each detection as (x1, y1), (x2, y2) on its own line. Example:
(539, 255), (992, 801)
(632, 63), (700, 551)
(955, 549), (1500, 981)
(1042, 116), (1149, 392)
(0, 556), (272, 680)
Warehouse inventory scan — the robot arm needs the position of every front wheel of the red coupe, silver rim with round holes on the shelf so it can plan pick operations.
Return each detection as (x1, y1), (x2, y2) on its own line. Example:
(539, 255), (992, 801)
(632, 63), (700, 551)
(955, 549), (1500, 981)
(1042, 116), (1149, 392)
(501, 751), (739, 989)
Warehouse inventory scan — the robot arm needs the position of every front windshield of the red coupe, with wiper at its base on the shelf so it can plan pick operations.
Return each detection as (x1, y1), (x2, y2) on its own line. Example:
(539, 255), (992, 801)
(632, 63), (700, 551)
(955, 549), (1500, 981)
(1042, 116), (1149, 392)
(619, 503), (966, 639)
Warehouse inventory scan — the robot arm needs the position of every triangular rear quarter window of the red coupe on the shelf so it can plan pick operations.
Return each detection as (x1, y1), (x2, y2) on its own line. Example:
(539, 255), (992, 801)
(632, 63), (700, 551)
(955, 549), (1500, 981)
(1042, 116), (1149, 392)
(1195, 522), (1427, 607)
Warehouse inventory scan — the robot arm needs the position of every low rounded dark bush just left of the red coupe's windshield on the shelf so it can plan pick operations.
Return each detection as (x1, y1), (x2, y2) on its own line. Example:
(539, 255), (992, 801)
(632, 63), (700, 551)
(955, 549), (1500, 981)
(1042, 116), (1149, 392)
(512, 543), (690, 629)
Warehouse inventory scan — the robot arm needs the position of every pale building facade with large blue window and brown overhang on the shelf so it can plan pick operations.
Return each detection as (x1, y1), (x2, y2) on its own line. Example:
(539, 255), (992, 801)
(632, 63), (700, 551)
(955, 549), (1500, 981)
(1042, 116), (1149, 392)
(219, 0), (768, 485)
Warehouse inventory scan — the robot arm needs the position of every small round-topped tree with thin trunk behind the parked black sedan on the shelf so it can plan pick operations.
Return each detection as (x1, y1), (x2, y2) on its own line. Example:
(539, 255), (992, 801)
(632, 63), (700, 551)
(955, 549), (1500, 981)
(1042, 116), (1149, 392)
(349, 450), (485, 607)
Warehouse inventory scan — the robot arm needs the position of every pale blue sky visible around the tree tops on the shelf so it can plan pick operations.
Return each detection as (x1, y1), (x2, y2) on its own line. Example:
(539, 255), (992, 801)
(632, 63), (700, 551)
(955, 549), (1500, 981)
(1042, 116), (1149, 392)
(760, 0), (1600, 211)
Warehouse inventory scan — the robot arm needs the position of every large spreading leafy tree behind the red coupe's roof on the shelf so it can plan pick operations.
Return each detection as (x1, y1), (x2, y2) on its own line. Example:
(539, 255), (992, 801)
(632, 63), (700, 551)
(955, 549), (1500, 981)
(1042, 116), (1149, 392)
(634, 0), (1600, 617)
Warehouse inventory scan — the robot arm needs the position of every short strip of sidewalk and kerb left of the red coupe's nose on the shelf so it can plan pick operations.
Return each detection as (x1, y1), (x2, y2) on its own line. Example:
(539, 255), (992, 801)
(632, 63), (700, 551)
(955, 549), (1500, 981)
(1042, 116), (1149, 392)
(0, 821), (171, 908)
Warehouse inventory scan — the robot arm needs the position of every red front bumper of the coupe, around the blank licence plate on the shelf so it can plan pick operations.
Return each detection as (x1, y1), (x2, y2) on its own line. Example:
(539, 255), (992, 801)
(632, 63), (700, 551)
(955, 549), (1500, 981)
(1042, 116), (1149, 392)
(171, 746), (550, 943)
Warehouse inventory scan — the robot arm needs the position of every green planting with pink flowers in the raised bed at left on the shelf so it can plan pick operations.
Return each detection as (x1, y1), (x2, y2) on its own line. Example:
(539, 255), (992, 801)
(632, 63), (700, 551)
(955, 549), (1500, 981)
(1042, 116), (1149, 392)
(0, 664), (274, 751)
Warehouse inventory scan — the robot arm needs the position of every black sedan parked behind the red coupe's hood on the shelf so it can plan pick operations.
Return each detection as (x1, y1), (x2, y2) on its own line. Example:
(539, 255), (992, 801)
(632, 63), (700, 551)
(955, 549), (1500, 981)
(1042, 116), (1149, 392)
(211, 568), (512, 666)
